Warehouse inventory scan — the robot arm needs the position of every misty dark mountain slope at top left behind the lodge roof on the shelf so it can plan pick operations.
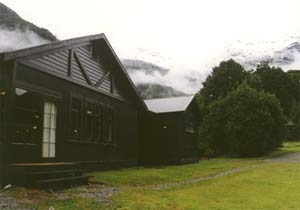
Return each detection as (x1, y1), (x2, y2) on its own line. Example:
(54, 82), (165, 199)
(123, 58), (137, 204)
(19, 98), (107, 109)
(0, 3), (57, 52)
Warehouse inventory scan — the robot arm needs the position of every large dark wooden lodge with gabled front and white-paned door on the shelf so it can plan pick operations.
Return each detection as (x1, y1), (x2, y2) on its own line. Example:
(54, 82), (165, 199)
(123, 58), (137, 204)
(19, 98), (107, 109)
(0, 34), (146, 185)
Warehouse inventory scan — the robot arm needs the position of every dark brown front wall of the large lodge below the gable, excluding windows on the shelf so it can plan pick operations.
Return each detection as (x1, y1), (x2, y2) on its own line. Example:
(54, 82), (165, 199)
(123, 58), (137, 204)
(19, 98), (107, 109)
(5, 64), (138, 166)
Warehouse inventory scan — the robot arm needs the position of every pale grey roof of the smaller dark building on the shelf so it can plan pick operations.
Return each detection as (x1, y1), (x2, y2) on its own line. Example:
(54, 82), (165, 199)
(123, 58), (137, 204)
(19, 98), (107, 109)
(145, 95), (195, 113)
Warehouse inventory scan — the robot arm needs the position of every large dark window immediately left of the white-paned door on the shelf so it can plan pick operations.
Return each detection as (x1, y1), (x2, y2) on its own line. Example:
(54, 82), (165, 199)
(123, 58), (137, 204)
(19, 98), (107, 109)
(12, 88), (43, 144)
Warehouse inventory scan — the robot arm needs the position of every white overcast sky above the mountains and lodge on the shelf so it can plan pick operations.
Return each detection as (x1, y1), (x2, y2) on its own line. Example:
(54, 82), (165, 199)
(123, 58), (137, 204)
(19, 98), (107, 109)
(1, 0), (300, 92)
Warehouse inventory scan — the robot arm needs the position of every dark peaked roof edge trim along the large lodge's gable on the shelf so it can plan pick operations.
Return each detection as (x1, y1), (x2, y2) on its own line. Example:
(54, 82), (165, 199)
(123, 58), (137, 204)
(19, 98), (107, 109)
(0, 33), (146, 108)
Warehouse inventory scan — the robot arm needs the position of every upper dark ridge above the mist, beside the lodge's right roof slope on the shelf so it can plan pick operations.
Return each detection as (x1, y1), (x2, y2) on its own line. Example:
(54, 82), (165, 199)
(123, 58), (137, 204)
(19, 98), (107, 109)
(122, 59), (169, 76)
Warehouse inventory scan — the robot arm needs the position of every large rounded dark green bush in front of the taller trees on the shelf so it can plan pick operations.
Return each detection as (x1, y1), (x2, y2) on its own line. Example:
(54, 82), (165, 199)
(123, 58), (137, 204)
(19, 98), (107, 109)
(200, 84), (284, 156)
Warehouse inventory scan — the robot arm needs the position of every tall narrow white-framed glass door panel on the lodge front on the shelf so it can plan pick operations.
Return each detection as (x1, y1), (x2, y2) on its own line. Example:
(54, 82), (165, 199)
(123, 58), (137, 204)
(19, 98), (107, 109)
(43, 102), (57, 158)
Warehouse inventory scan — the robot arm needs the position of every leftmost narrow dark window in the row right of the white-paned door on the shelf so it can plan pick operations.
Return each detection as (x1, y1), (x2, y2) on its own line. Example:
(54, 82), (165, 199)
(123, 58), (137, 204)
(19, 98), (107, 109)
(70, 98), (81, 140)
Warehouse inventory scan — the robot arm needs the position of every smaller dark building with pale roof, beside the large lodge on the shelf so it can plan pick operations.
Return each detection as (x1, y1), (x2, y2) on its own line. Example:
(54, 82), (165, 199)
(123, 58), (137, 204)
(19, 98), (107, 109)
(140, 95), (198, 164)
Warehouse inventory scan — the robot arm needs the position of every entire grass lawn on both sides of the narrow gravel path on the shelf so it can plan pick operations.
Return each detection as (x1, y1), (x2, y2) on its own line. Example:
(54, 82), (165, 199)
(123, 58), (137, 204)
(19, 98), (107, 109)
(0, 143), (300, 210)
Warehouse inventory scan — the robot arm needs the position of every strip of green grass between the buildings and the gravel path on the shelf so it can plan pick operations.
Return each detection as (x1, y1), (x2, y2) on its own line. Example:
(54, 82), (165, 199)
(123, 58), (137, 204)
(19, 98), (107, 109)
(89, 158), (261, 186)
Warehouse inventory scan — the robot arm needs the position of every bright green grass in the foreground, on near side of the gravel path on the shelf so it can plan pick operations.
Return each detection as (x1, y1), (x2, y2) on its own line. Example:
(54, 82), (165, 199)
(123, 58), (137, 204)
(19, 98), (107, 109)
(111, 163), (300, 210)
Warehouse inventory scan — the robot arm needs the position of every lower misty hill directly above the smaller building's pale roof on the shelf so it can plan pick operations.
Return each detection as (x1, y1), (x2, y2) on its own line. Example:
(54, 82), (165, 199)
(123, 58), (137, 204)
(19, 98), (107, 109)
(136, 83), (186, 99)
